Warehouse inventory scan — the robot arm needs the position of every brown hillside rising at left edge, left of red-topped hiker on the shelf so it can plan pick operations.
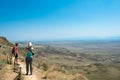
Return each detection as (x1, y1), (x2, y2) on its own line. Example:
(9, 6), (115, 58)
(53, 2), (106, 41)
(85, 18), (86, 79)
(0, 36), (13, 80)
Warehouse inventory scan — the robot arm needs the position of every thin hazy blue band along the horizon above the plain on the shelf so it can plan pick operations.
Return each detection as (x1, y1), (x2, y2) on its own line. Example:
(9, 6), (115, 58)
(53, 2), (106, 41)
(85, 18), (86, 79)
(9, 37), (120, 42)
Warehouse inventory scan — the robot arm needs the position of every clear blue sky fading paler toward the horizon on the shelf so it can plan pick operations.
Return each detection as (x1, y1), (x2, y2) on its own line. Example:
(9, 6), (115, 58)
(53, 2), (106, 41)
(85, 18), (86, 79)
(0, 0), (120, 41)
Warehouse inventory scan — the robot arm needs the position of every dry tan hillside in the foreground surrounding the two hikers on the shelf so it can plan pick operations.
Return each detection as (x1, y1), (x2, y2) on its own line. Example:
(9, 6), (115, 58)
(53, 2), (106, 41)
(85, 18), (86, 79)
(0, 37), (88, 80)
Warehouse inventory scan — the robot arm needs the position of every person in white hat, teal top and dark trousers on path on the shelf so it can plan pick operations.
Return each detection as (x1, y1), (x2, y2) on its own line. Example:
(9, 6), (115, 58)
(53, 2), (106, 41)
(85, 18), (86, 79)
(25, 42), (33, 75)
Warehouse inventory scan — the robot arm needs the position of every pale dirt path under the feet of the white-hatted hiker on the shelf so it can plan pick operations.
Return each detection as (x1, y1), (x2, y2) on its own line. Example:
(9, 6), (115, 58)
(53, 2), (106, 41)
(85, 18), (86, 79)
(20, 63), (38, 80)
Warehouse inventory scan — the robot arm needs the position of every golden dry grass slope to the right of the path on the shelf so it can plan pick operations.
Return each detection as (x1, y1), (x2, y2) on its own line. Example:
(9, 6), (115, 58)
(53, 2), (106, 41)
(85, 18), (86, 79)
(34, 61), (88, 80)
